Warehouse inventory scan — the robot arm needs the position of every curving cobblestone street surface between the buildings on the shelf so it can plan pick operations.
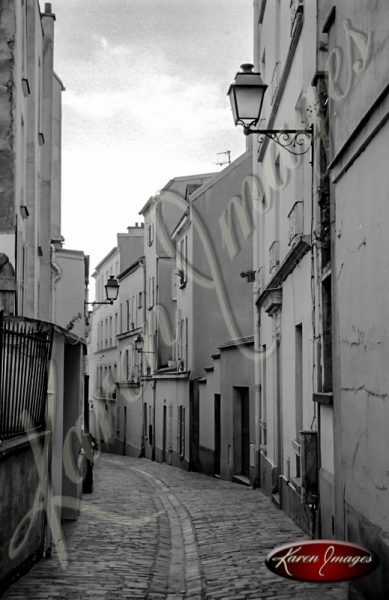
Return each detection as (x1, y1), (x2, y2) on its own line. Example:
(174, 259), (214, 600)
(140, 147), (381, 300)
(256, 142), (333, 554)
(5, 454), (347, 600)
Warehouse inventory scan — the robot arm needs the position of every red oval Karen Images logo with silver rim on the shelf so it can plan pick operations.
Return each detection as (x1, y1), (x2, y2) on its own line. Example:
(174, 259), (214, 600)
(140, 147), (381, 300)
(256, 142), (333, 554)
(266, 540), (379, 583)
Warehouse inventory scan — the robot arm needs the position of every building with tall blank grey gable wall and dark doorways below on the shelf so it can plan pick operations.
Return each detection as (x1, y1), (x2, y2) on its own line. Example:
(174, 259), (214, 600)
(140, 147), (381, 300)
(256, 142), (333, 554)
(169, 152), (255, 483)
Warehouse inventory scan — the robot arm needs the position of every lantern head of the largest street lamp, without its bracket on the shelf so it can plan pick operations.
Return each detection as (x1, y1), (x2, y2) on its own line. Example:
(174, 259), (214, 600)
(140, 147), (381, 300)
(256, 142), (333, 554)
(228, 65), (267, 125)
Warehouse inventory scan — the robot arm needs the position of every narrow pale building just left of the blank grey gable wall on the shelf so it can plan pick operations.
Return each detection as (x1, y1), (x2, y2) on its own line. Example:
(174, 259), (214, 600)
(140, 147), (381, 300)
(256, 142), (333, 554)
(140, 174), (213, 468)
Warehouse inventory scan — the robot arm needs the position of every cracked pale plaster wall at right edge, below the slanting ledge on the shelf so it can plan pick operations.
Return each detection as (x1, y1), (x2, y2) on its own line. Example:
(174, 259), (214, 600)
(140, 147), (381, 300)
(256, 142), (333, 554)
(335, 124), (389, 531)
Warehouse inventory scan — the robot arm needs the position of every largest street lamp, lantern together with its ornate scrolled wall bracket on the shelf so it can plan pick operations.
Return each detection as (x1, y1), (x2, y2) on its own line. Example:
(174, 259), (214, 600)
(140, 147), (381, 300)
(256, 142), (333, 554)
(227, 63), (313, 156)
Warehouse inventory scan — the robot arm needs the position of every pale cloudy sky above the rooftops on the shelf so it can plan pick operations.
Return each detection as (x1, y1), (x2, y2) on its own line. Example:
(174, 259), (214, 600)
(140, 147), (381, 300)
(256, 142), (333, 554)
(50, 0), (253, 274)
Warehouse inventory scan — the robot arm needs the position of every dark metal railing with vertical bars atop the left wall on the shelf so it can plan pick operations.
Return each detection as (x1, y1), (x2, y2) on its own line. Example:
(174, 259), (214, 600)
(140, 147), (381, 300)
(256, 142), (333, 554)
(0, 312), (53, 440)
